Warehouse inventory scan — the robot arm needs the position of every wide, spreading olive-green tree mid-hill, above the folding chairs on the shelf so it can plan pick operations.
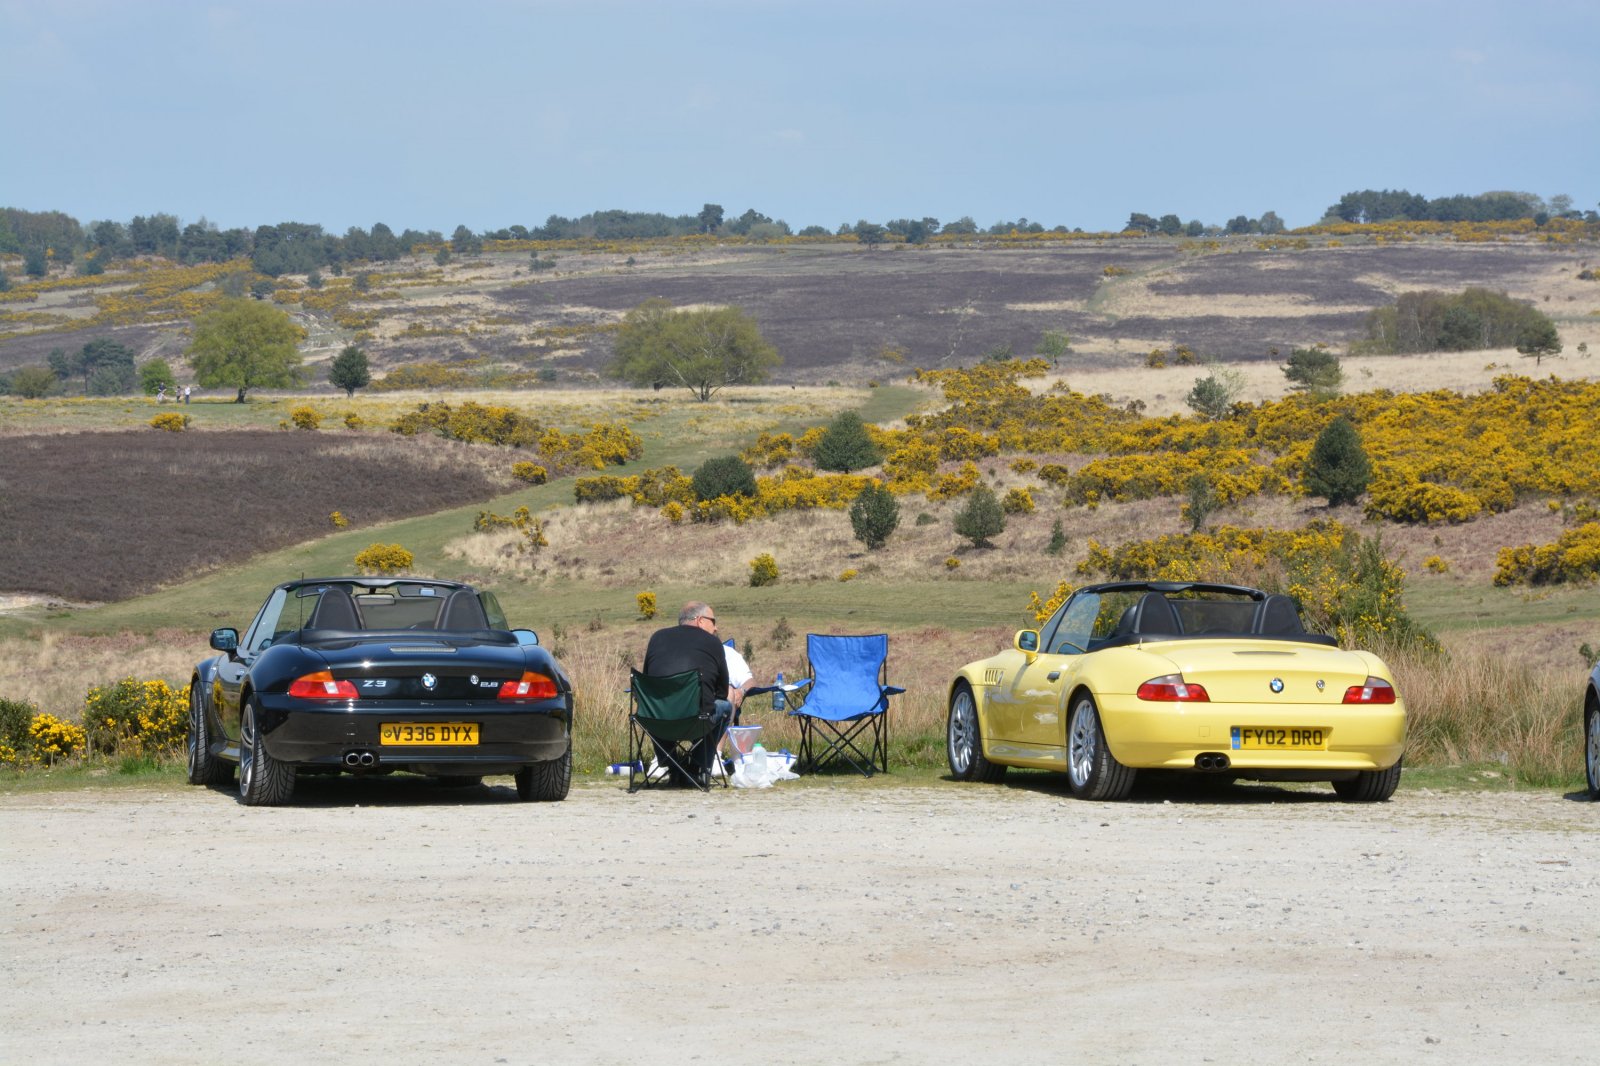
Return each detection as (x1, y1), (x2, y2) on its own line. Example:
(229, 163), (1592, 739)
(610, 298), (782, 400)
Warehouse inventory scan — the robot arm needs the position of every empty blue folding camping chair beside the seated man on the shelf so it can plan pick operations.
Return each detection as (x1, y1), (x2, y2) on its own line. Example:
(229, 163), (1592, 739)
(789, 632), (906, 778)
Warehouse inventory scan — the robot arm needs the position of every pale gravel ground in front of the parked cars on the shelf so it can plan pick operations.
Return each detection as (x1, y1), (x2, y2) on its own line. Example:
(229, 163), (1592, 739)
(0, 773), (1600, 1064)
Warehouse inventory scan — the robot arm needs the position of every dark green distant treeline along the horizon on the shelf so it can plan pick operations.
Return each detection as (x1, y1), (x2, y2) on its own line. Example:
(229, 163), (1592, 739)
(0, 189), (1600, 277)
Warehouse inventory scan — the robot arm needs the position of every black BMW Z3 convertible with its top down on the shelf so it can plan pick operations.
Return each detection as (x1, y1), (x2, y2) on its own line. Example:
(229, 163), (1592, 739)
(189, 578), (573, 807)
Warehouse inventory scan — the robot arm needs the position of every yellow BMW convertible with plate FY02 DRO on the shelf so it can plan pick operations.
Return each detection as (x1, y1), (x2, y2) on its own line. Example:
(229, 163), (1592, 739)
(947, 581), (1405, 802)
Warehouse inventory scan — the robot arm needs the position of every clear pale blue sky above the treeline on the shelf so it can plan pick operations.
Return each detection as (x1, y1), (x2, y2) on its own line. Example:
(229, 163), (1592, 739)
(0, 0), (1600, 234)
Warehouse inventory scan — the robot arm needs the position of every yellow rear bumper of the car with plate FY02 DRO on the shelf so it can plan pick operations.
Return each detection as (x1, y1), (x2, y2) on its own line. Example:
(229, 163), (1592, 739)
(1099, 695), (1405, 770)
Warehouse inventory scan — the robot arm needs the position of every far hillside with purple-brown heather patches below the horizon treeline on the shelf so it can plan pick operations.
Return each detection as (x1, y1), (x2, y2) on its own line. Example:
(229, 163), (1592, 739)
(0, 237), (1600, 384)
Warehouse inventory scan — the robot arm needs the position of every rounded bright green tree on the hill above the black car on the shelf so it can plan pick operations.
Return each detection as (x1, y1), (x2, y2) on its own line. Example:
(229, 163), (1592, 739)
(189, 299), (306, 403)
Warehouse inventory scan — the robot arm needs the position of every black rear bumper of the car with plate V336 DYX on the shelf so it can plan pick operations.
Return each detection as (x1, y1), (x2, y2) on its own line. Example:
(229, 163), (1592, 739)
(259, 698), (571, 773)
